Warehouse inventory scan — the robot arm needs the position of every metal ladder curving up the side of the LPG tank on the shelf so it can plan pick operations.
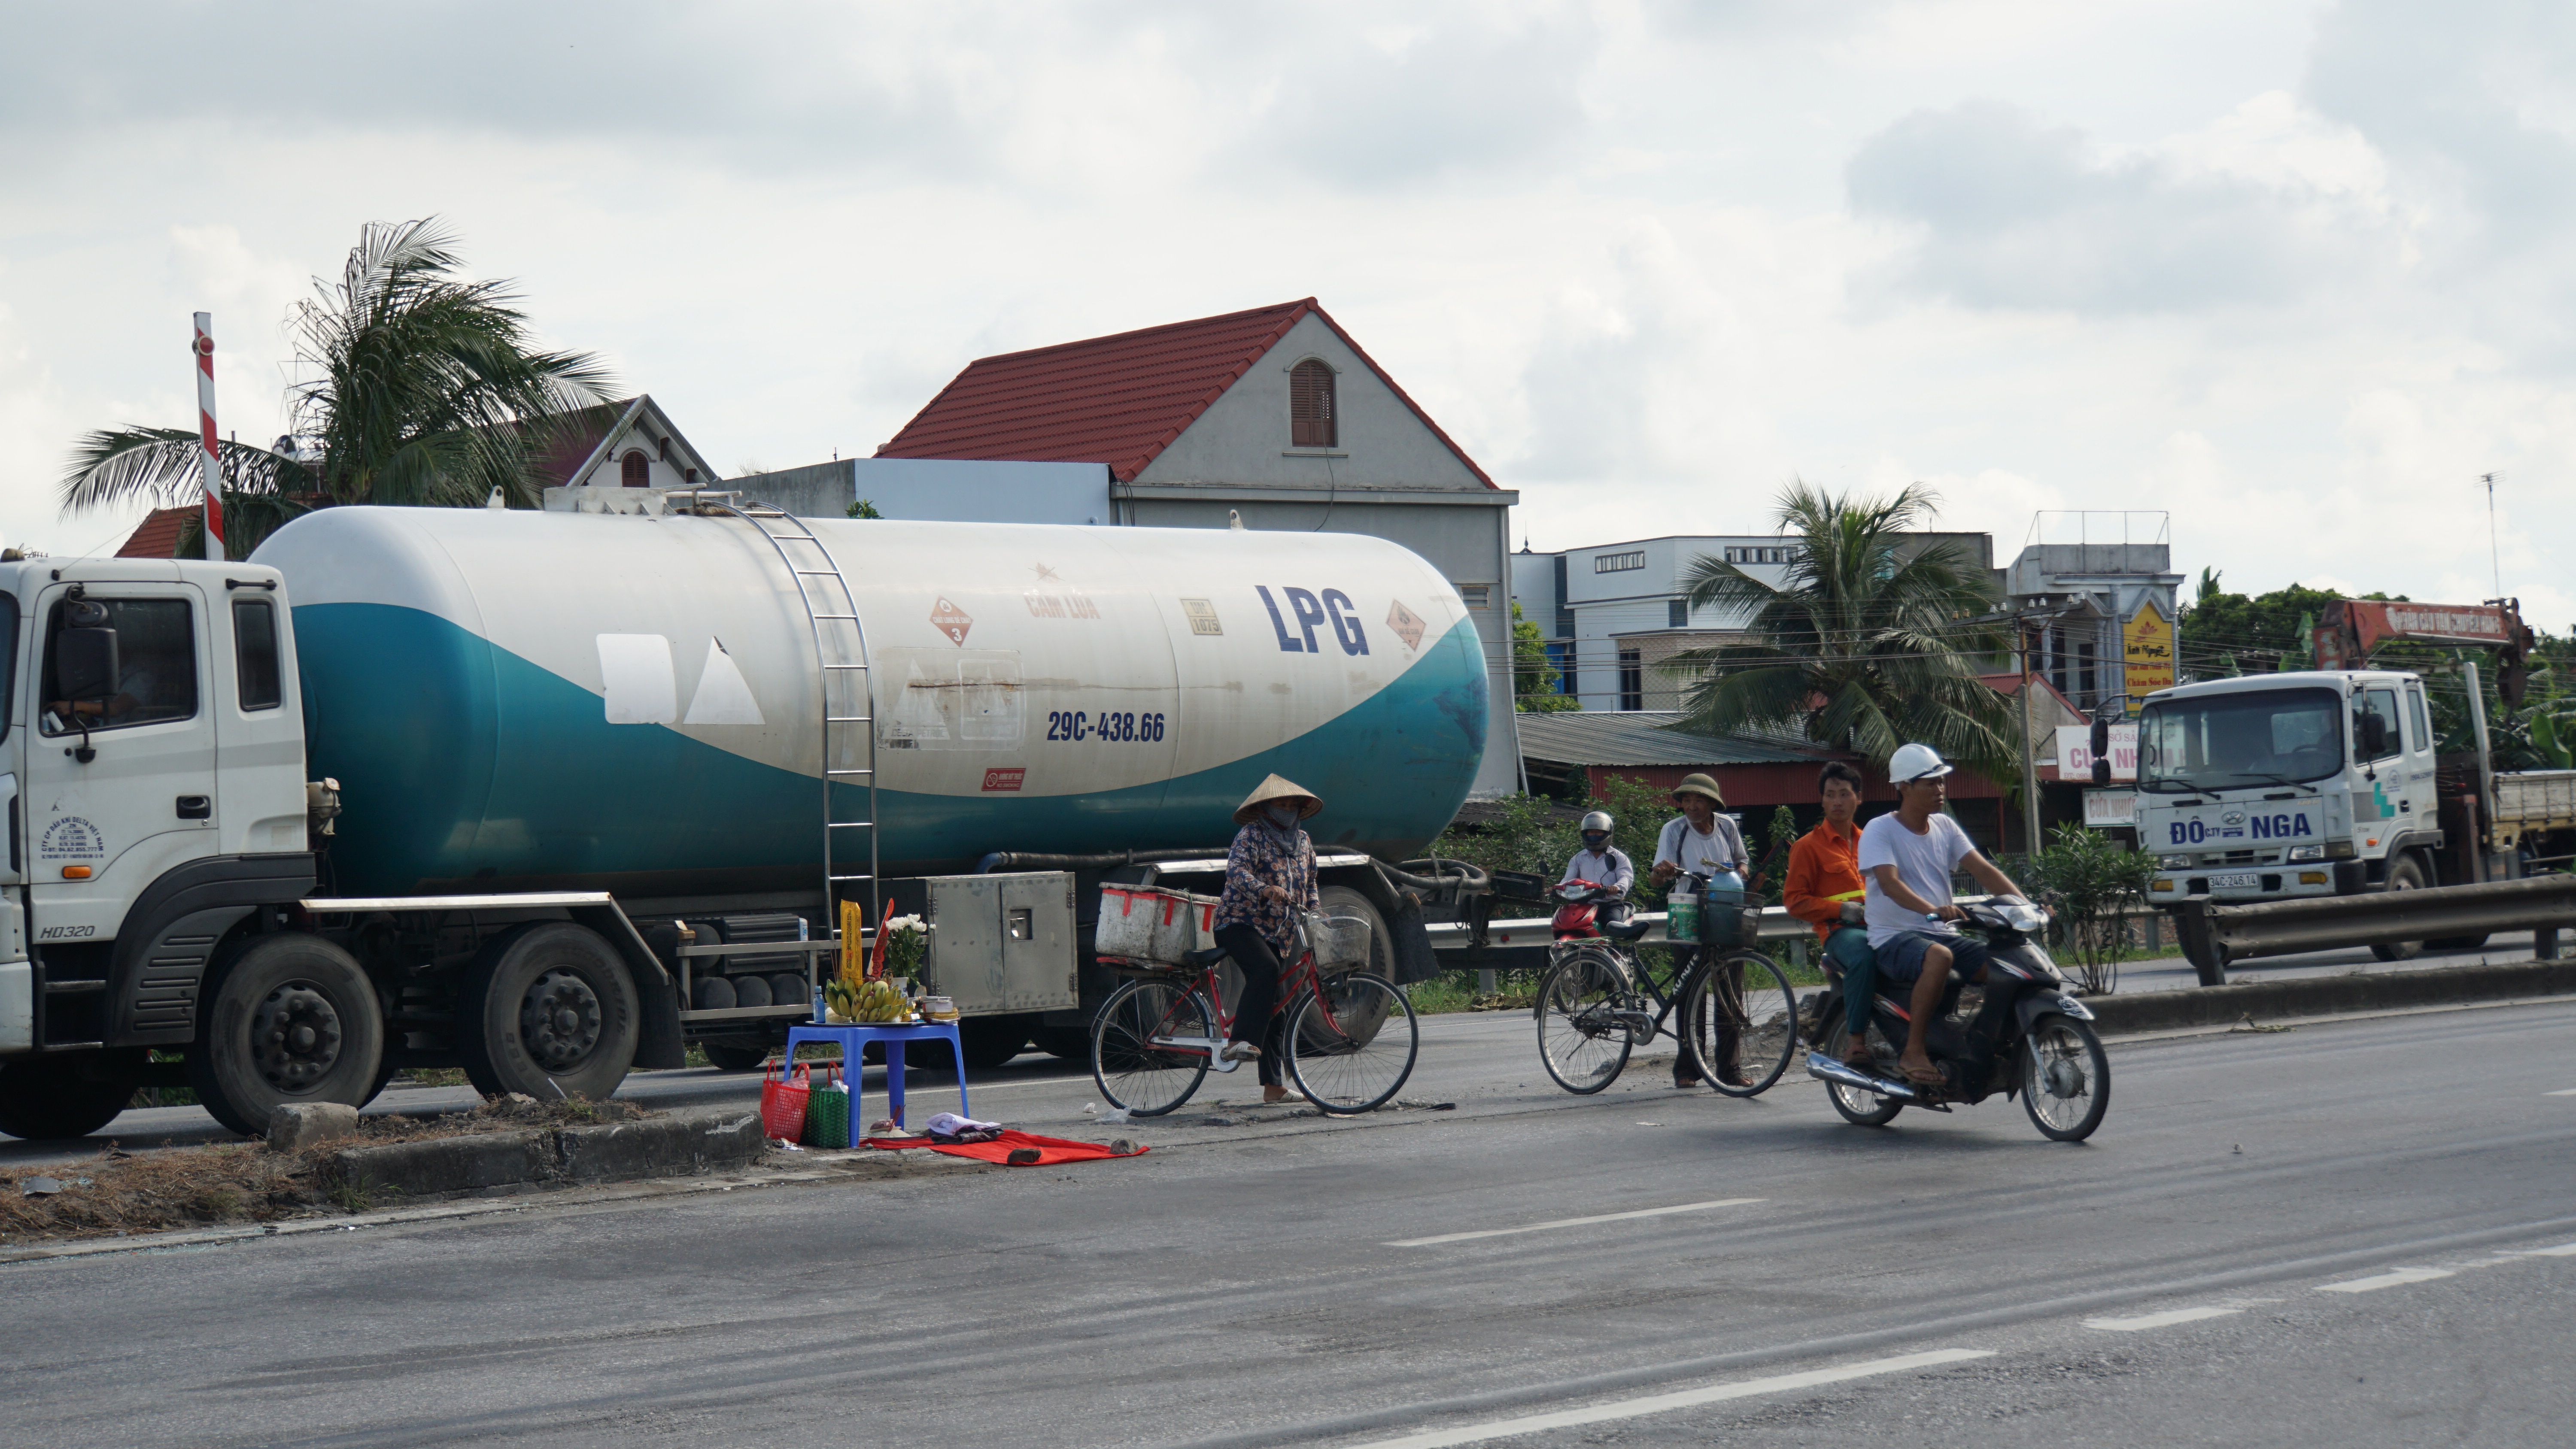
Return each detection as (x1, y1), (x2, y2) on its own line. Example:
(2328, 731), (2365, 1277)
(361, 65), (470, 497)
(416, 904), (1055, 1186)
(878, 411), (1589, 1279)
(701, 499), (881, 937)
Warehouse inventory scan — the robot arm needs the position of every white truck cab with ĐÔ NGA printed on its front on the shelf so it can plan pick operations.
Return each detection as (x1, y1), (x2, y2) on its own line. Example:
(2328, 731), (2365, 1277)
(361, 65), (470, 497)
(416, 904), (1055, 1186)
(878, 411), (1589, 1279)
(2136, 669), (2442, 906)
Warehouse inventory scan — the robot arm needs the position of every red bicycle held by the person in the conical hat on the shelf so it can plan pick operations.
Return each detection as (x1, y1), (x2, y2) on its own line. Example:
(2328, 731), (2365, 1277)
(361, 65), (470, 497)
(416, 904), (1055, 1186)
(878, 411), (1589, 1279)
(1092, 911), (1422, 1117)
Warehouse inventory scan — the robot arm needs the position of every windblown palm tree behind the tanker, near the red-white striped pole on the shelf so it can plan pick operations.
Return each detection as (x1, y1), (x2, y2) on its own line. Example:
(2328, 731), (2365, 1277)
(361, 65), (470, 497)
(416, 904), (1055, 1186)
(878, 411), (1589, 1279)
(62, 216), (611, 558)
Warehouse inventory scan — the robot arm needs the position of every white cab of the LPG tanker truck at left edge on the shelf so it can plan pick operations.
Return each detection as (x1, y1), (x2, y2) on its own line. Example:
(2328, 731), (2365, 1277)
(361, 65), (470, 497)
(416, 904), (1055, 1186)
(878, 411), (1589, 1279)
(0, 558), (314, 1117)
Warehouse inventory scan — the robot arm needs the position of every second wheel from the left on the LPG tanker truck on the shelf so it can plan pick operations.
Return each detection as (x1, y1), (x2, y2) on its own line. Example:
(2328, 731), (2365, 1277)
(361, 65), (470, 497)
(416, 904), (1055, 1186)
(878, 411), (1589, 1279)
(188, 932), (384, 1137)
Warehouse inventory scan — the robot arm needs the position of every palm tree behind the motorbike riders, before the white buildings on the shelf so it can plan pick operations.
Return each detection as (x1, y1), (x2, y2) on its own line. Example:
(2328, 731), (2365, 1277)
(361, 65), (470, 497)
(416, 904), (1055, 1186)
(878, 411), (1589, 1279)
(1664, 481), (2020, 782)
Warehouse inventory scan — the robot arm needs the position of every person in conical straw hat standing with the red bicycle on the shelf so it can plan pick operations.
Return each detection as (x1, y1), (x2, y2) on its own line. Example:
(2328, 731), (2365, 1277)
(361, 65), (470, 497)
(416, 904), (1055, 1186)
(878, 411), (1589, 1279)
(1216, 775), (1324, 1101)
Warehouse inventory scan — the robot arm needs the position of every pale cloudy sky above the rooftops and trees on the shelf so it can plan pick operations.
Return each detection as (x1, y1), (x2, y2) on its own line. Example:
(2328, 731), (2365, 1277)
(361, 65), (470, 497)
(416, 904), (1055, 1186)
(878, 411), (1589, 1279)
(0, 0), (2576, 631)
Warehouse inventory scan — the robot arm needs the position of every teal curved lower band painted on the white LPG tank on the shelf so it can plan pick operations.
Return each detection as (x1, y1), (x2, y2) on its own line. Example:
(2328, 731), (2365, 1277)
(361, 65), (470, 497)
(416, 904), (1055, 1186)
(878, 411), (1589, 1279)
(294, 602), (1489, 896)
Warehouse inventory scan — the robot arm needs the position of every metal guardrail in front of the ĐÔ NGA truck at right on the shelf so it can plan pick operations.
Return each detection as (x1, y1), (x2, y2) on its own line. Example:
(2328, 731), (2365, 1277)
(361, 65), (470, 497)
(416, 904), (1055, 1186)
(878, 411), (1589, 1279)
(2174, 875), (2576, 986)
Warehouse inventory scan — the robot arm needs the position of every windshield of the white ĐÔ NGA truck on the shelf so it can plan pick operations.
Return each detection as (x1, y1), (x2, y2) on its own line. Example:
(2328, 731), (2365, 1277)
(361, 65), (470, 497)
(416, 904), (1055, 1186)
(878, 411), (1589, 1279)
(2138, 690), (2344, 795)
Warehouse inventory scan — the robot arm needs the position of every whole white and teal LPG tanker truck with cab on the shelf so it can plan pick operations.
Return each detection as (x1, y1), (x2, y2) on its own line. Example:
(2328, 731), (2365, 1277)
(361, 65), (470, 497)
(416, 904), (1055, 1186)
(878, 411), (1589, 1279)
(0, 489), (1486, 1137)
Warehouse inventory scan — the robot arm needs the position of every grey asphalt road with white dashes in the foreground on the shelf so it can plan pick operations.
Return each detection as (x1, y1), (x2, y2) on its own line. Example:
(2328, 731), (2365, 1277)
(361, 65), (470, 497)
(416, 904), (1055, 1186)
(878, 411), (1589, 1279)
(0, 1004), (2576, 1449)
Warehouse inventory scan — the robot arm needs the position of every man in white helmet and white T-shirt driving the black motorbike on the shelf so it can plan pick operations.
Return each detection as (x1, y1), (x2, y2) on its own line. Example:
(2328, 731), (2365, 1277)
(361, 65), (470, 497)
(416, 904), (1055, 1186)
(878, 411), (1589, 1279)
(1860, 744), (2022, 1084)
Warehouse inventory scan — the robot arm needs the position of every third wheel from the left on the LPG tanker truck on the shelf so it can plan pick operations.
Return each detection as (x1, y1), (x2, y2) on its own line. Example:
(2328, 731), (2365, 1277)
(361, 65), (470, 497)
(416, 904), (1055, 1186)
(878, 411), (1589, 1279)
(456, 922), (641, 1101)
